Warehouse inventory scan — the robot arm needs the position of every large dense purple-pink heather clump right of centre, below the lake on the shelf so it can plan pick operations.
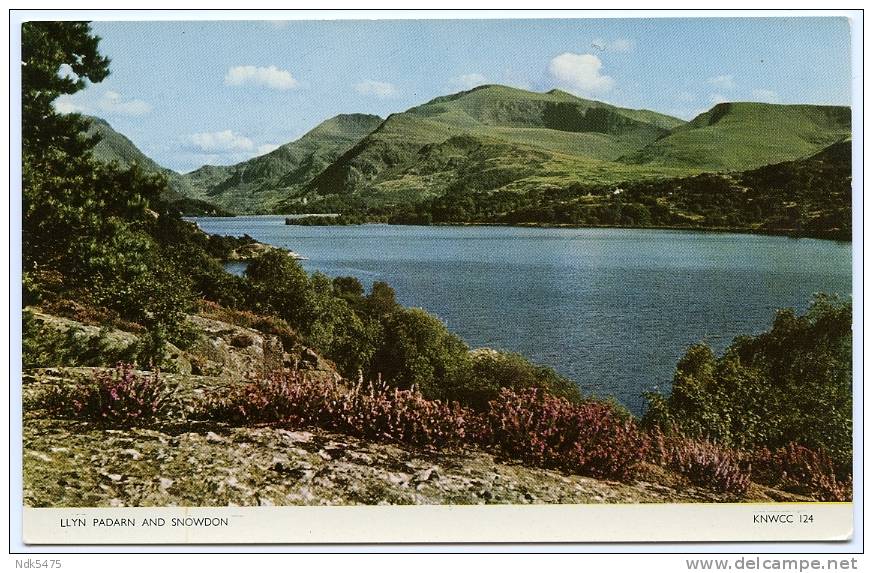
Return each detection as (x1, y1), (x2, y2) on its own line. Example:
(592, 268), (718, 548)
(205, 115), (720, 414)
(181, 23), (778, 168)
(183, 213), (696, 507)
(485, 388), (647, 479)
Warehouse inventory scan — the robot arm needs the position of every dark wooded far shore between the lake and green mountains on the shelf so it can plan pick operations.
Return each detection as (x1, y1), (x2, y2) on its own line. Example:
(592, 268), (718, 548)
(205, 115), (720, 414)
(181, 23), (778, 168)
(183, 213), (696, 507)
(295, 140), (852, 240)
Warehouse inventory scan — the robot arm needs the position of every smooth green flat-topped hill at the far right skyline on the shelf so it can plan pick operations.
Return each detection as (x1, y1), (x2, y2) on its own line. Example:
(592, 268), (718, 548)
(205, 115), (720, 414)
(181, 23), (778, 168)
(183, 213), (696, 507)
(622, 103), (851, 171)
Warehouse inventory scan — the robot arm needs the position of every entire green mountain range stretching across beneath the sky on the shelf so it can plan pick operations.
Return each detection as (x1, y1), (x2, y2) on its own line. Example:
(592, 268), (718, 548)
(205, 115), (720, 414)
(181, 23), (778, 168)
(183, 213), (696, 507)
(78, 84), (851, 214)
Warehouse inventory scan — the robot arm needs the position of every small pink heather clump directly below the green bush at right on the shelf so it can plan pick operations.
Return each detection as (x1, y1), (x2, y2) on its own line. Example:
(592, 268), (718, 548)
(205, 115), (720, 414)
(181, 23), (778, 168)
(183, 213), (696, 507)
(650, 431), (751, 495)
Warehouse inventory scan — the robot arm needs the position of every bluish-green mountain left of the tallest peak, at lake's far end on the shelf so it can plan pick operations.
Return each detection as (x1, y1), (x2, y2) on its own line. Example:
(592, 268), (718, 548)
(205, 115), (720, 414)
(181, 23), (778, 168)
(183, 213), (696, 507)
(183, 114), (382, 213)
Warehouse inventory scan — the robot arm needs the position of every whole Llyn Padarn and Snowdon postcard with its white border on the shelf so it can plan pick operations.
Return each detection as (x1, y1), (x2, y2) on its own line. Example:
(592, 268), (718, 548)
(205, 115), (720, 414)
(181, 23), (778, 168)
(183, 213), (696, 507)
(13, 12), (861, 546)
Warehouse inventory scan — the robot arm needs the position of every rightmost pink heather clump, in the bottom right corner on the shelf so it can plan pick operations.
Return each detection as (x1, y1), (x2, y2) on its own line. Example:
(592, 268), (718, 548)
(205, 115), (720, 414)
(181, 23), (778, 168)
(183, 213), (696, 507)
(752, 443), (852, 501)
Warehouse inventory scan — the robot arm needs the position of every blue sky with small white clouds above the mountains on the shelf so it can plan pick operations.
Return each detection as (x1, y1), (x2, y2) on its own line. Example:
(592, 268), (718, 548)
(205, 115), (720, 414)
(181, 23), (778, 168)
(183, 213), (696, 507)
(56, 18), (851, 172)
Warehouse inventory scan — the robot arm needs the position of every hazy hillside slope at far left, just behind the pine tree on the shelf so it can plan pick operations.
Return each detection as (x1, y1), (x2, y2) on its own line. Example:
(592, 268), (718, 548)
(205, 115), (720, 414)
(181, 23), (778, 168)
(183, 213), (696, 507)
(85, 116), (226, 215)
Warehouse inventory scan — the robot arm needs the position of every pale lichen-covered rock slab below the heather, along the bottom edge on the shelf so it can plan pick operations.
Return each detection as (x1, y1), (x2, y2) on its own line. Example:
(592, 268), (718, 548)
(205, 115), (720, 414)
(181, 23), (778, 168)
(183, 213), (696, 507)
(24, 418), (804, 507)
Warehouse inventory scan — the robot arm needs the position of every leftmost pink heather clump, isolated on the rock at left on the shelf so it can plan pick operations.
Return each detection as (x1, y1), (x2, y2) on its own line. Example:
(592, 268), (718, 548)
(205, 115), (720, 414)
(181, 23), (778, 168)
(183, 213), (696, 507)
(44, 364), (172, 427)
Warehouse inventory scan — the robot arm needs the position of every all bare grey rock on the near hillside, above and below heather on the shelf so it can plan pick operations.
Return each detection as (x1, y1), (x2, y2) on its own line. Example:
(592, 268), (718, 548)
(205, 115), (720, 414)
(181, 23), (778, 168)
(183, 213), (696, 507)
(22, 315), (802, 507)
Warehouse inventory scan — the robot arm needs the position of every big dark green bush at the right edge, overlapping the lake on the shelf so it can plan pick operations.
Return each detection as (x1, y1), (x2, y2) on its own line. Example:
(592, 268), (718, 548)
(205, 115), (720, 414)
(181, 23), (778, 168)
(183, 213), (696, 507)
(645, 297), (852, 476)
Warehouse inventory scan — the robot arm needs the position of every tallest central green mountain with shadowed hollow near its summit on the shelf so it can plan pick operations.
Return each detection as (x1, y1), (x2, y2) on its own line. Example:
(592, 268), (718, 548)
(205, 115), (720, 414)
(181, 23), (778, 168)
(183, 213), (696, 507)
(286, 85), (684, 205)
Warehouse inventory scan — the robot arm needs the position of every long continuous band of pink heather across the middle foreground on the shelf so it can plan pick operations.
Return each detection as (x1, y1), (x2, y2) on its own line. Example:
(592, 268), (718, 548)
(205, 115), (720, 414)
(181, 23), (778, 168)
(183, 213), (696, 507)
(203, 374), (646, 479)
